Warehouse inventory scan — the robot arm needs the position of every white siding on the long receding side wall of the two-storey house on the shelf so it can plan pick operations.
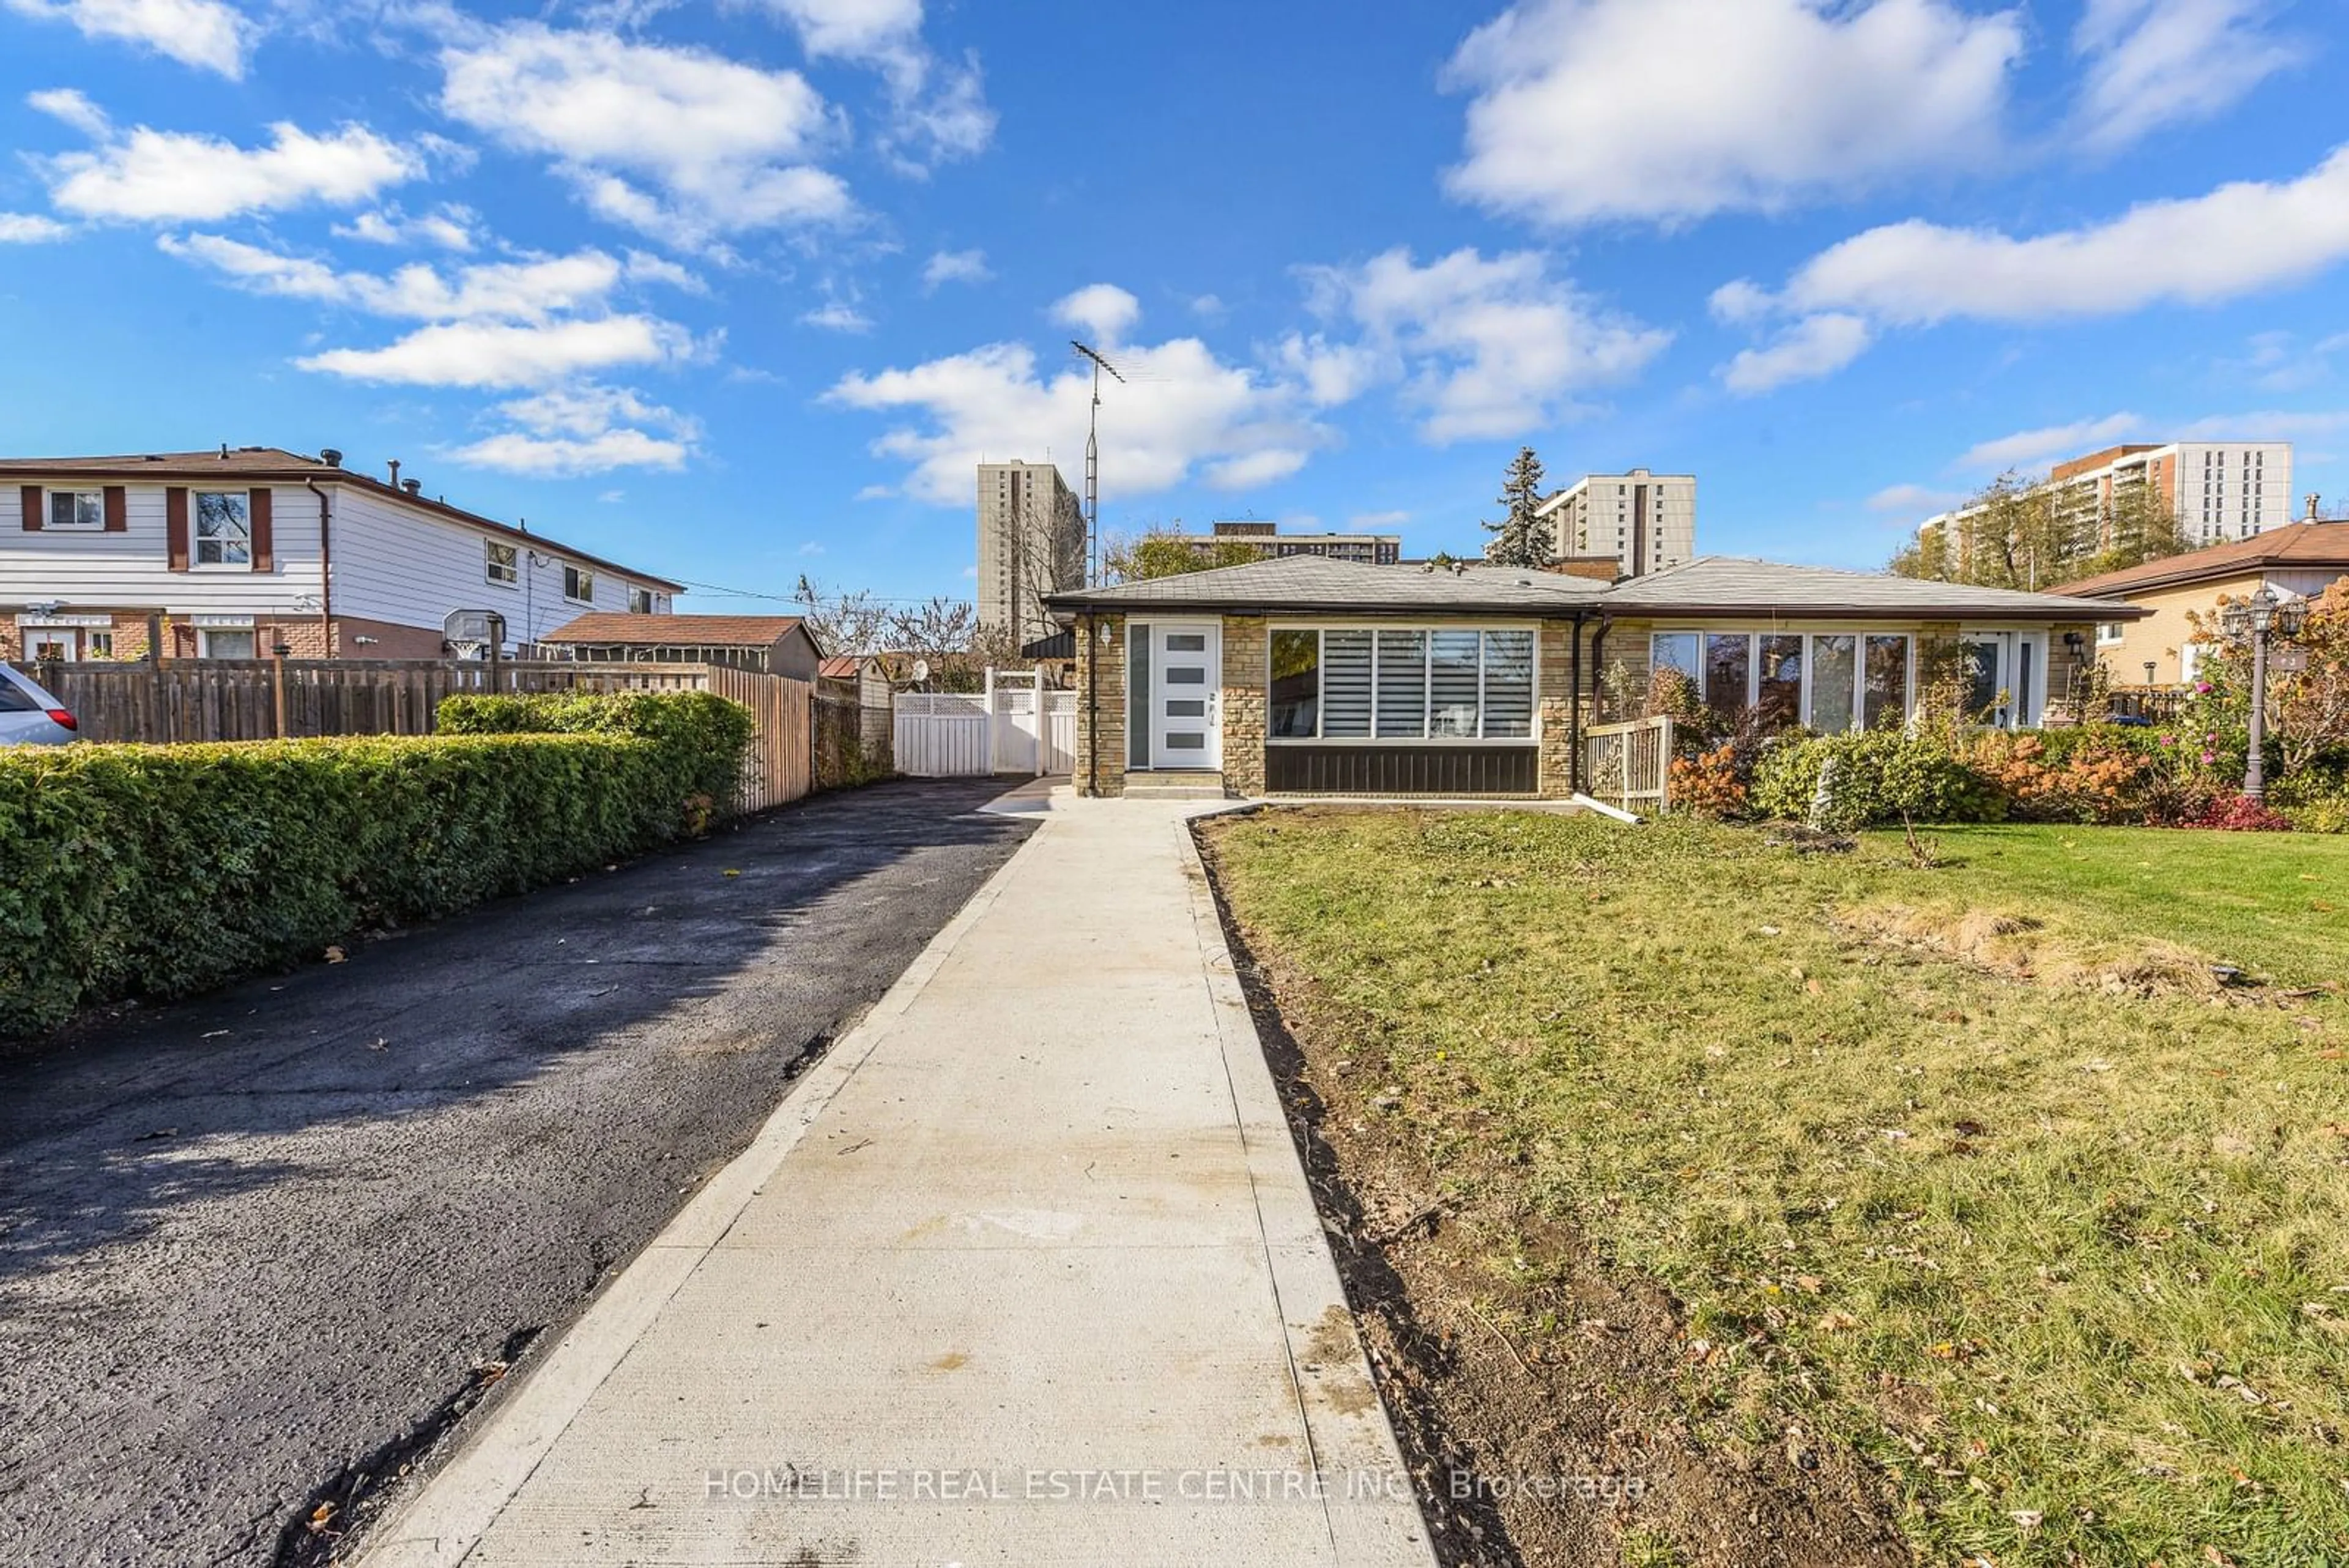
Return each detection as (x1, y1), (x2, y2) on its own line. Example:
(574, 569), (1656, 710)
(333, 489), (667, 642)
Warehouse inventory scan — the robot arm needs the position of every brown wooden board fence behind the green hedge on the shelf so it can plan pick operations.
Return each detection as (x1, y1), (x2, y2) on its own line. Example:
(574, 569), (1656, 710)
(33, 658), (815, 811)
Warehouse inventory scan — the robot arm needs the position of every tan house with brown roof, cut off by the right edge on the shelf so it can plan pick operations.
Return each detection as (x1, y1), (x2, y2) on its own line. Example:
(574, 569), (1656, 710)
(2055, 519), (2349, 686)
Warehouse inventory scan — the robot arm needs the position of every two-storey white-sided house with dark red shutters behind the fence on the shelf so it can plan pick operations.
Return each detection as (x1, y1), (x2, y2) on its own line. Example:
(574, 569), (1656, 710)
(0, 447), (683, 658)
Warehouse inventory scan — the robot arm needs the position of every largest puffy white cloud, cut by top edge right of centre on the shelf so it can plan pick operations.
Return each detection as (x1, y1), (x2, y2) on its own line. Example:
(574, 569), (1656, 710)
(1447, 0), (2022, 223)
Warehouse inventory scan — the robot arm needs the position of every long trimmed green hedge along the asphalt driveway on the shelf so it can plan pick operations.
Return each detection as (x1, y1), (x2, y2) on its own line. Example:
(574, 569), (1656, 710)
(0, 694), (749, 1037)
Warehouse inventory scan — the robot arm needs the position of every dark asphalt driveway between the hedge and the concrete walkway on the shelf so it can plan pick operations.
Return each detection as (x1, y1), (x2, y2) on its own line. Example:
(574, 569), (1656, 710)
(0, 781), (1031, 1566)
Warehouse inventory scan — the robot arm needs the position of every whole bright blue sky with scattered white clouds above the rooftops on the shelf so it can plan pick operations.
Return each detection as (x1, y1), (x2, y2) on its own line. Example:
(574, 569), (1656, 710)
(0, 0), (2349, 609)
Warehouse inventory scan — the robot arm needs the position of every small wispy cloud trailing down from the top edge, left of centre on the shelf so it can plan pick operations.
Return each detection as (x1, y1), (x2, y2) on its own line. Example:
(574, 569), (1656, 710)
(763, 0), (996, 174)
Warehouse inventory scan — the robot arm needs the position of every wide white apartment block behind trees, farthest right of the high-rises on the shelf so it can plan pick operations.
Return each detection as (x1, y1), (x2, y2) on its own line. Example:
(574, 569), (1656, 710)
(1917, 442), (2293, 550)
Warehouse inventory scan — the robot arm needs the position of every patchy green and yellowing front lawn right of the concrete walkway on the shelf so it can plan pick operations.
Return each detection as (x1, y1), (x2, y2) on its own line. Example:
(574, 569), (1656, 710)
(1210, 811), (2349, 1568)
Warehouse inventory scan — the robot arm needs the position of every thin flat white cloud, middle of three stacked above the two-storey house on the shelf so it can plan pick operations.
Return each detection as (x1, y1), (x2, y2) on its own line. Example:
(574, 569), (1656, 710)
(296, 315), (693, 388)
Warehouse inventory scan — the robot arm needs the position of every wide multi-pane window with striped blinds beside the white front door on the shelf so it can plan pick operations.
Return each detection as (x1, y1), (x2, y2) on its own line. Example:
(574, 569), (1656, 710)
(1266, 628), (1534, 740)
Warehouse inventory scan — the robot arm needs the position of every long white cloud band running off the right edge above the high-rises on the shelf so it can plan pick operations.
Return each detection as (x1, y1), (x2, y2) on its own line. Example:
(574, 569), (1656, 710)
(1785, 146), (2349, 327)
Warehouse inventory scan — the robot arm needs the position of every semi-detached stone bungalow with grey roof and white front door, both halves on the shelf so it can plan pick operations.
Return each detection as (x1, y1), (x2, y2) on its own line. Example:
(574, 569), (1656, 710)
(1048, 555), (2142, 799)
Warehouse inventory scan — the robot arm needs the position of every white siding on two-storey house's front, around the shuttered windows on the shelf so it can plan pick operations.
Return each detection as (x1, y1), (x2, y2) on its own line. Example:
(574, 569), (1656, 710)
(0, 480), (317, 616)
